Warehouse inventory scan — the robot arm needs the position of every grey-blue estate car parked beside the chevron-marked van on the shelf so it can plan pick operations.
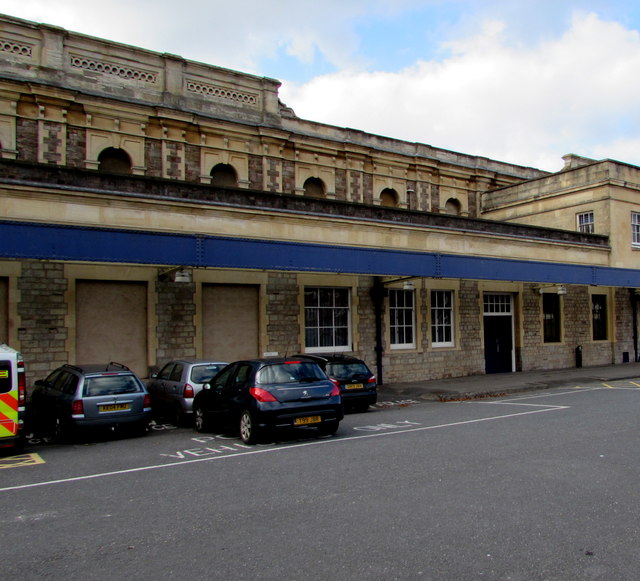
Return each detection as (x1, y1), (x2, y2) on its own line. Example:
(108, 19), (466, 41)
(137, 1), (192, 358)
(31, 362), (151, 440)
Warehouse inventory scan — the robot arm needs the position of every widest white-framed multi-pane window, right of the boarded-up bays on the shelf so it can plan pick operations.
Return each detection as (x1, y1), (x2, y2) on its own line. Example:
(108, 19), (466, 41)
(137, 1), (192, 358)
(304, 287), (351, 351)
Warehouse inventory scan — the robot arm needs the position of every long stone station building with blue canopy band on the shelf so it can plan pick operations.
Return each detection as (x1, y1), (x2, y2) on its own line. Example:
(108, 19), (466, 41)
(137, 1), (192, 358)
(0, 16), (640, 382)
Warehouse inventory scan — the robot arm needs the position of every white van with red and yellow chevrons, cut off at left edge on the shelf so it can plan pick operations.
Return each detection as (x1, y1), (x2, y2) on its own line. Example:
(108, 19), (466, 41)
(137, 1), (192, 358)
(0, 345), (26, 449)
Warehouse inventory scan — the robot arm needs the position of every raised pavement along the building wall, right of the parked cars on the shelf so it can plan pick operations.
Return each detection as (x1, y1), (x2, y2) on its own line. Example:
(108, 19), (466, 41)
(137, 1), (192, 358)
(378, 363), (640, 402)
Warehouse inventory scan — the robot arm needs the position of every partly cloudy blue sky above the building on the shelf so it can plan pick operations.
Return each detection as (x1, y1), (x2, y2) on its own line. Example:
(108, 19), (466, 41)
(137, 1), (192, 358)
(0, 0), (640, 171)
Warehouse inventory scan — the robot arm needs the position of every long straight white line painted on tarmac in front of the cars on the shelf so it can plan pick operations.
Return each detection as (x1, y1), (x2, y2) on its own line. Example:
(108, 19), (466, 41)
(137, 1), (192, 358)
(0, 406), (567, 493)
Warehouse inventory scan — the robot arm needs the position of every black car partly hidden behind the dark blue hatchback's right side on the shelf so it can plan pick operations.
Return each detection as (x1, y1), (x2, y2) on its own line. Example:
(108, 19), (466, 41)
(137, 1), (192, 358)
(295, 354), (378, 411)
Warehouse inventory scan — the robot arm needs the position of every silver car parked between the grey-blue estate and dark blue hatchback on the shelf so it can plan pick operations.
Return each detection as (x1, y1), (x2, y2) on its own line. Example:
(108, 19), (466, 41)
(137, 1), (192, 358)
(147, 359), (227, 426)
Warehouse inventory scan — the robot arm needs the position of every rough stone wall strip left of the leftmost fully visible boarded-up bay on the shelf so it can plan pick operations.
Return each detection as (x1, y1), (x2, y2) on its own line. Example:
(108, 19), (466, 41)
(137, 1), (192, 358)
(18, 261), (68, 382)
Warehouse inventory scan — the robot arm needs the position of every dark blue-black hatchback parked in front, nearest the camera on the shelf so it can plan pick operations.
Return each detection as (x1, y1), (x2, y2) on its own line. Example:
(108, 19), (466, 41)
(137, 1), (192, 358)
(193, 358), (343, 444)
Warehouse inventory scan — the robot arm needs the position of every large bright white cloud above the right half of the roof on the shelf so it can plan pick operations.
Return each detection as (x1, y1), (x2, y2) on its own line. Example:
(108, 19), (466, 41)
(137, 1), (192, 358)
(282, 14), (640, 170)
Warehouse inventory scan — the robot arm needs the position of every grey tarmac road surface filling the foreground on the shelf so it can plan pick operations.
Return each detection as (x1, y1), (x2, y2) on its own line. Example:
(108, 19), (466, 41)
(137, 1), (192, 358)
(0, 379), (640, 581)
